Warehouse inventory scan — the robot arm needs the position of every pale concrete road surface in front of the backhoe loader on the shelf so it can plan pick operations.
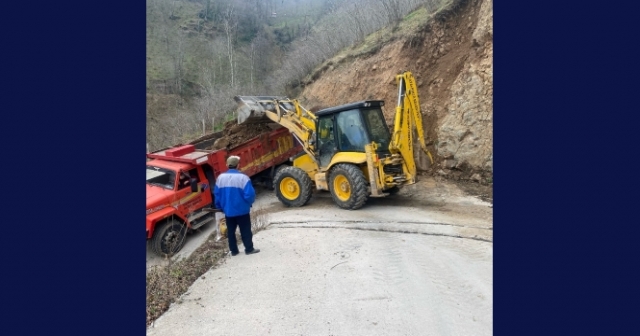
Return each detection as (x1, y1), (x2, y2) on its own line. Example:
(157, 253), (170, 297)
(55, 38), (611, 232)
(147, 178), (493, 335)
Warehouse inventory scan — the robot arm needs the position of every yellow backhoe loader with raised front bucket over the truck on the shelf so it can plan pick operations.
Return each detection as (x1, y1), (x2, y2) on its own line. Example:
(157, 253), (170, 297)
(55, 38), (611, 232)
(234, 72), (433, 210)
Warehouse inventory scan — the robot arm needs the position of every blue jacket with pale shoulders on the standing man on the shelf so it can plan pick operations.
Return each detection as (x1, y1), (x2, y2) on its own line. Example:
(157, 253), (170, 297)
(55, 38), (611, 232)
(213, 169), (256, 217)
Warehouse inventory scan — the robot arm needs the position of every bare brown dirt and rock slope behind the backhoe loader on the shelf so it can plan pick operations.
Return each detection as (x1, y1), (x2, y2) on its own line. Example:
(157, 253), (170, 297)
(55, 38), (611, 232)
(300, 0), (493, 183)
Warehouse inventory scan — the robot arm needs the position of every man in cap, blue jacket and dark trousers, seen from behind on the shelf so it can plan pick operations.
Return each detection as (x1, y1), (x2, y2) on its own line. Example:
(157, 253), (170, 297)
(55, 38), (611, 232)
(213, 156), (260, 256)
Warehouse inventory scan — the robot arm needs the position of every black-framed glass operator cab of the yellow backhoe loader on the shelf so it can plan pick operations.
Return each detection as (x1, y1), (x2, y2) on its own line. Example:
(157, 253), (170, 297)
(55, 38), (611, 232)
(316, 100), (391, 167)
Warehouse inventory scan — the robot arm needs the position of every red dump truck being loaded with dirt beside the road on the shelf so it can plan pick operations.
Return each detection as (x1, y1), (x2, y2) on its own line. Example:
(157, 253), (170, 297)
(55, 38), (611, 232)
(147, 128), (302, 256)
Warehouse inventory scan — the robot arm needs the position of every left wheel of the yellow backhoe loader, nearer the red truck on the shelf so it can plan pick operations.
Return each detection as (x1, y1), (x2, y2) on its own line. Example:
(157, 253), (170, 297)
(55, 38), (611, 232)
(273, 166), (313, 207)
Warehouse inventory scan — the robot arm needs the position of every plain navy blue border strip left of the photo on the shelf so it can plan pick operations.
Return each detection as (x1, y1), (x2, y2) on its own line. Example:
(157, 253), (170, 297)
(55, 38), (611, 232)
(0, 1), (146, 335)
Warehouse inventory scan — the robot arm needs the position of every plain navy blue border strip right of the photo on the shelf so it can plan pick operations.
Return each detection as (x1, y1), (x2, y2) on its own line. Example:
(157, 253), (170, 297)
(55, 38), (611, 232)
(494, 1), (640, 335)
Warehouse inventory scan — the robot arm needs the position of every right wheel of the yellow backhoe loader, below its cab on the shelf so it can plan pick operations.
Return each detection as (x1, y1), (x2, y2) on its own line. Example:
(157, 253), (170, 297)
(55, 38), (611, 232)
(329, 163), (369, 210)
